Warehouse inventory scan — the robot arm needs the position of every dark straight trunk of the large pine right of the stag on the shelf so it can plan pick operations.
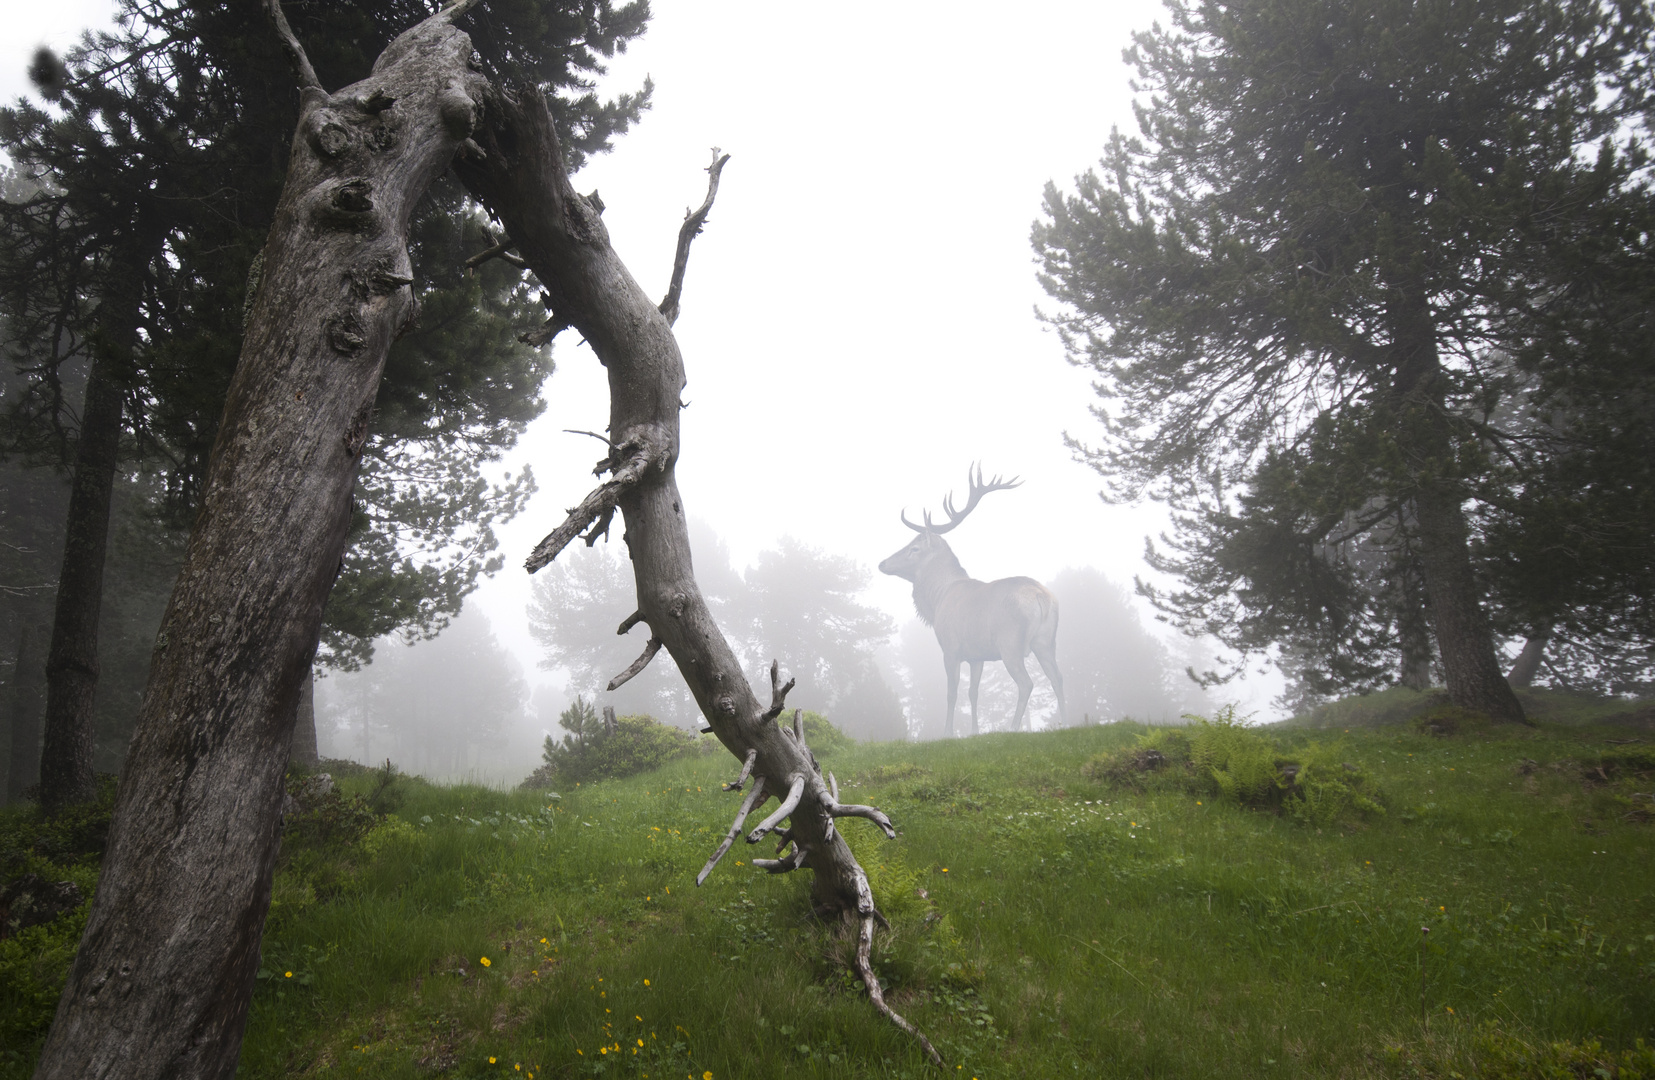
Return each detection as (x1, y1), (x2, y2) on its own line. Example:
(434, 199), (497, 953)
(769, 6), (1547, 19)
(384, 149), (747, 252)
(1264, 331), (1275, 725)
(1390, 292), (1526, 723)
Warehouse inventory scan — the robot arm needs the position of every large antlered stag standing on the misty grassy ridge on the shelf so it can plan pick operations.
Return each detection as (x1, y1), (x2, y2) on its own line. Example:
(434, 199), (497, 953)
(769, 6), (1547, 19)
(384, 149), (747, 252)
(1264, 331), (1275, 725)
(879, 466), (1064, 738)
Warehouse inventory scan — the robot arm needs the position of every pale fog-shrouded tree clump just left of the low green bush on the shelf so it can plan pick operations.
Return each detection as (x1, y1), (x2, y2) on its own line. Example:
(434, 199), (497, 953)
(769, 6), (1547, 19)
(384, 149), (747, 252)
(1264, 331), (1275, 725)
(318, 609), (535, 779)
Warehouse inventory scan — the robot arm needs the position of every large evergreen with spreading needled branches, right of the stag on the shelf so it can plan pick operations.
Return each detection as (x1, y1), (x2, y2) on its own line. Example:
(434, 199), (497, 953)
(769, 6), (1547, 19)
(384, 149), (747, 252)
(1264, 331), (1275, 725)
(1034, 0), (1652, 707)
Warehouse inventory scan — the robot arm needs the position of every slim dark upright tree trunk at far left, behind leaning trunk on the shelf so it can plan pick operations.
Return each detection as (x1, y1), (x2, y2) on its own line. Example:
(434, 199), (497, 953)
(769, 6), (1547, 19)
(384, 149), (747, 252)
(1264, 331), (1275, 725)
(40, 348), (125, 814)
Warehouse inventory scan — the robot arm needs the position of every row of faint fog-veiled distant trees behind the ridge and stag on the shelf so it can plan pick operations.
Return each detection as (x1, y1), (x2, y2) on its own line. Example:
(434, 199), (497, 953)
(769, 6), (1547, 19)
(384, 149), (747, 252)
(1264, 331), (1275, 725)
(316, 523), (1211, 784)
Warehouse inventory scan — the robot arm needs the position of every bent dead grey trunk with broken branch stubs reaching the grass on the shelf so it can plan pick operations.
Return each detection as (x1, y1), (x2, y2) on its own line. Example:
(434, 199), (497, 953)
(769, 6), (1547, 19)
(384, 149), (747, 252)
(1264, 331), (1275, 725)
(453, 88), (935, 1060)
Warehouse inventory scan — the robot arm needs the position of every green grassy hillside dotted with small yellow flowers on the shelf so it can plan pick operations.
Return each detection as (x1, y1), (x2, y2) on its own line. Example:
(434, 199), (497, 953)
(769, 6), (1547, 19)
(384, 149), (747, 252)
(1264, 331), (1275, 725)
(0, 704), (1655, 1080)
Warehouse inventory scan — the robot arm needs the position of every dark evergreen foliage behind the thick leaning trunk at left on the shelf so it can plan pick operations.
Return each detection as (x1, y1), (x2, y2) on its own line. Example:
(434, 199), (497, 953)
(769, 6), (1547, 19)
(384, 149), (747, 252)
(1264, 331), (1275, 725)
(0, 0), (649, 667)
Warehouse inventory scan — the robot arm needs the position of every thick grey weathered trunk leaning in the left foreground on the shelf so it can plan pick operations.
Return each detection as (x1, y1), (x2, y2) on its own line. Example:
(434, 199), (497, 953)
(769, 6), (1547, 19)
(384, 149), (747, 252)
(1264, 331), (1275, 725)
(35, 8), (483, 1080)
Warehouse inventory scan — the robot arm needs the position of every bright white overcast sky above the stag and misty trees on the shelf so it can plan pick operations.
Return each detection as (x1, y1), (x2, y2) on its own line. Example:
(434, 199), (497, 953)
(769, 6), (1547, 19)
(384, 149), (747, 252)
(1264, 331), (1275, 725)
(0, 0), (1279, 718)
